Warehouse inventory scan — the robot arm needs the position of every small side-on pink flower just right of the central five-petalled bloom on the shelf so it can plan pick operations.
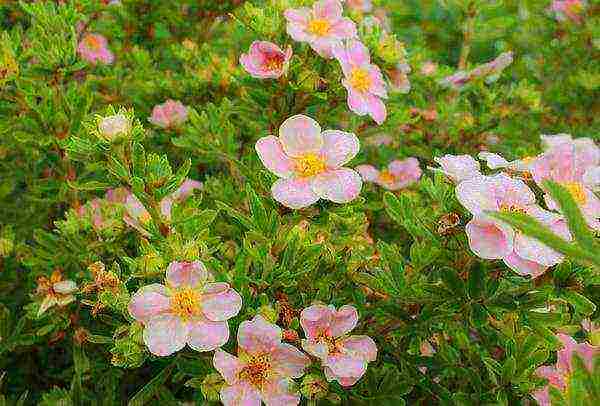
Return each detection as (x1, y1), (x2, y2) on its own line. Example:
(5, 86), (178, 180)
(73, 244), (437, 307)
(354, 158), (422, 190)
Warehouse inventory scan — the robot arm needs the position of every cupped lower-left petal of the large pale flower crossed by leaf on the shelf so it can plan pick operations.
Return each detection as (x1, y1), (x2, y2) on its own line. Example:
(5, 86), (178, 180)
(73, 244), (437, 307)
(465, 218), (514, 259)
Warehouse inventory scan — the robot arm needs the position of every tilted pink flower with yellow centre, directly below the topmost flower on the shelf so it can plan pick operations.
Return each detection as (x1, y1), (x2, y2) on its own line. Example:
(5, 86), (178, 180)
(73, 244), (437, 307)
(333, 40), (387, 124)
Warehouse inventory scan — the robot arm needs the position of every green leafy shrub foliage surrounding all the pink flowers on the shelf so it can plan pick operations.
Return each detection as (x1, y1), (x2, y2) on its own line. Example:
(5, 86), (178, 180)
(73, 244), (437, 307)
(0, 0), (600, 405)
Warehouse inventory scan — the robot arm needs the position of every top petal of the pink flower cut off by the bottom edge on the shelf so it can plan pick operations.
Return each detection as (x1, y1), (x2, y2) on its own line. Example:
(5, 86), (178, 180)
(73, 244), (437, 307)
(238, 315), (282, 354)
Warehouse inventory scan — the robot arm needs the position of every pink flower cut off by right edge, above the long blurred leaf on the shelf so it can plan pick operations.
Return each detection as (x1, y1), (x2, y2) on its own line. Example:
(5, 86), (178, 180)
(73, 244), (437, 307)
(531, 136), (600, 230)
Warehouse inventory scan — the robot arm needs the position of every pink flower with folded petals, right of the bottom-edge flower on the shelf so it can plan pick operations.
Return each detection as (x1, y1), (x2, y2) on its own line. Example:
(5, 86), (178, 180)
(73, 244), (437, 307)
(300, 305), (377, 386)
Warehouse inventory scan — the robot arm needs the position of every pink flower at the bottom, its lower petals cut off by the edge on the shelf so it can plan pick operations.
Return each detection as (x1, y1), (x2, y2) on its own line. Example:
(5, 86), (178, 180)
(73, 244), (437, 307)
(213, 315), (310, 406)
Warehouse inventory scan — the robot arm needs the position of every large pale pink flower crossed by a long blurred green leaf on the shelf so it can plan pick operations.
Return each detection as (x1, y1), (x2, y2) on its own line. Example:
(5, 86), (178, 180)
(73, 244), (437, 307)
(456, 173), (570, 277)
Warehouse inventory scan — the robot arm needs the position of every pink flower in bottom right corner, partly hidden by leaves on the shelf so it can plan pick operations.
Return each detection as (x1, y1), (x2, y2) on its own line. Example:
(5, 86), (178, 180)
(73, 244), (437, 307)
(533, 333), (600, 406)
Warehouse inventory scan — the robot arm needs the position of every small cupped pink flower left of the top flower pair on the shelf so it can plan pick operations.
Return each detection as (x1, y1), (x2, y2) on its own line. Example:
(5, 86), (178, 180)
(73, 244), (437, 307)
(240, 41), (292, 79)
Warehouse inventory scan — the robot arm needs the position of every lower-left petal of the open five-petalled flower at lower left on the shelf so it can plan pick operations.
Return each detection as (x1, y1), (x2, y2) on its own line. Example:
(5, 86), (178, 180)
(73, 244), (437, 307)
(144, 314), (189, 357)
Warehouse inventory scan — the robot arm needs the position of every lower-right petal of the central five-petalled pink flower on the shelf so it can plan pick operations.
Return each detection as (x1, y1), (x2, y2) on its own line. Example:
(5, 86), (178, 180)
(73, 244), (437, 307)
(311, 168), (362, 203)
